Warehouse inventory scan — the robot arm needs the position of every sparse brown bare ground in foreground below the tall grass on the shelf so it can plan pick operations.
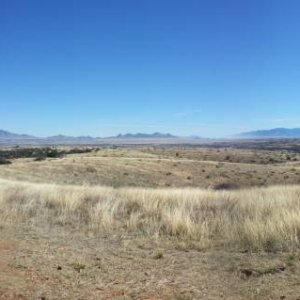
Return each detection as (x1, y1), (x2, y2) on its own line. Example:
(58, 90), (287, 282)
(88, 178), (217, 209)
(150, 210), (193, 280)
(0, 226), (300, 300)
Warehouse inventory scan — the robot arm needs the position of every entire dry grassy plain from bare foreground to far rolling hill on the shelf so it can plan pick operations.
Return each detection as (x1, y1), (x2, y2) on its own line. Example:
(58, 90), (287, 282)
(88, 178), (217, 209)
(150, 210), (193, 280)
(0, 141), (300, 300)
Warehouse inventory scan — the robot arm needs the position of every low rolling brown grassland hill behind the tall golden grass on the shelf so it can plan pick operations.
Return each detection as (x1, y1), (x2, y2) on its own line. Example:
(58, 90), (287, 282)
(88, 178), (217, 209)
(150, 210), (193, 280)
(0, 147), (300, 189)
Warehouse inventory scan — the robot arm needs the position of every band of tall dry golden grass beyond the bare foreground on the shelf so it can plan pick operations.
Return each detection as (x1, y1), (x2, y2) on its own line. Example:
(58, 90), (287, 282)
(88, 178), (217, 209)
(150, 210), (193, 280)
(0, 180), (300, 251)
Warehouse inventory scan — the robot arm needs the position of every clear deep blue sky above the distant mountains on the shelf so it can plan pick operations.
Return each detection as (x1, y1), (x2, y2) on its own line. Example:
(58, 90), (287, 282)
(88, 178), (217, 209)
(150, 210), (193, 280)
(0, 0), (300, 137)
